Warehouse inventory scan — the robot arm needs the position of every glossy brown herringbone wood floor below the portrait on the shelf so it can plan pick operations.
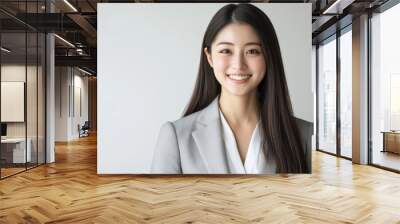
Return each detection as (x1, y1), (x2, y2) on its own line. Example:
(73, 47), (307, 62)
(0, 134), (400, 224)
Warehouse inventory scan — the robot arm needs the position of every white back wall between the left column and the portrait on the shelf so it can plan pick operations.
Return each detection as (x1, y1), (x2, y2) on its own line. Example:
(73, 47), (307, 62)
(55, 67), (88, 141)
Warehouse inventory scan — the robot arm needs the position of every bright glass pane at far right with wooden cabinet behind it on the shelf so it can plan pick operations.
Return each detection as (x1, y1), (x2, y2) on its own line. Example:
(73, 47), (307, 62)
(371, 4), (400, 170)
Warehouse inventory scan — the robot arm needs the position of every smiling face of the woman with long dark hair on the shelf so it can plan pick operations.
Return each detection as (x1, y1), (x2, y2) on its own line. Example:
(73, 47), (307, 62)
(204, 23), (266, 96)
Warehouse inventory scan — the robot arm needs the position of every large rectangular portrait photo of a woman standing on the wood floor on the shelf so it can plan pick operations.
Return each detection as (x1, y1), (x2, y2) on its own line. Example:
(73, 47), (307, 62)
(98, 3), (313, 174)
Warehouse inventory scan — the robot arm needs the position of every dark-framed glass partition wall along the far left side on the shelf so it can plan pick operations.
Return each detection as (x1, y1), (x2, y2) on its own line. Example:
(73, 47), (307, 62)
(0, 1), (46, 179)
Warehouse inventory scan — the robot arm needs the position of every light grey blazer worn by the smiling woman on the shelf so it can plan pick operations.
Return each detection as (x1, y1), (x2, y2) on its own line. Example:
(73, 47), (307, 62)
(151, 97), (312, 174)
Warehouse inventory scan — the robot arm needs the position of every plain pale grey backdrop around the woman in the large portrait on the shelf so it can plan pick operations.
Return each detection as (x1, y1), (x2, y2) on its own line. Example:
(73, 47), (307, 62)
(97, 3), (313, 174)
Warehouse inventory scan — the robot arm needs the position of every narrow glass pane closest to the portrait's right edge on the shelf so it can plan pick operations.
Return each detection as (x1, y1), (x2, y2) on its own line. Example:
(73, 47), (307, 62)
(318, 38), (336, 154)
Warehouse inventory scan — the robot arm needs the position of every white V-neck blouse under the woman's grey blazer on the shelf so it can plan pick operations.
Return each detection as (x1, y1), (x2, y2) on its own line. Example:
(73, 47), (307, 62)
(219, 110), (275, 174)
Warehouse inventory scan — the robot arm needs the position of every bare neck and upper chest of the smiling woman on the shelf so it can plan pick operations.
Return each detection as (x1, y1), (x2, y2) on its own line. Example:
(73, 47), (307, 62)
(219, 91), (259, 126)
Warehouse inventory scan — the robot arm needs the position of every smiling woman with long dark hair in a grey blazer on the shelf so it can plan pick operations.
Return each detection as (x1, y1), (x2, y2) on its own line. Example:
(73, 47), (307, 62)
(152, 4), (312, 174)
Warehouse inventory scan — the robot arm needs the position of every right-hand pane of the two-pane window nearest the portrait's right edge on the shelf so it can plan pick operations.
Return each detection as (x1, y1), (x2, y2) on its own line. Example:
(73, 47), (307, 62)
(340, 30), (353, 158)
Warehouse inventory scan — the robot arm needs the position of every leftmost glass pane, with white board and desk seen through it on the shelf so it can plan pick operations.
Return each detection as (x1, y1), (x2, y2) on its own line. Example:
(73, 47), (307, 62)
(0, 32), (30, 178)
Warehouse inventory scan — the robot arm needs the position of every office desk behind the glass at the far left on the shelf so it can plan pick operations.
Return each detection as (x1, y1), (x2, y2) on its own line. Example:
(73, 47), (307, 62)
(1, 138), (32, 163)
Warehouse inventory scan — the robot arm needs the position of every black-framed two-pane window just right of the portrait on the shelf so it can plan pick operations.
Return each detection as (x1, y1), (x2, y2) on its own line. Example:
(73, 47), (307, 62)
(317, 25), (353, 159)
